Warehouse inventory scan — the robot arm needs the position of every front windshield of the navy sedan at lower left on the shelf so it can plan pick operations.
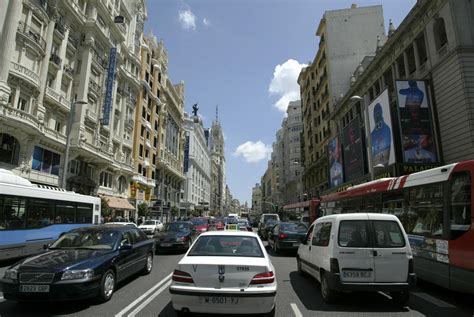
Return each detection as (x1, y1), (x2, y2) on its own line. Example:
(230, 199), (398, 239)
(50, 231), (119, 250)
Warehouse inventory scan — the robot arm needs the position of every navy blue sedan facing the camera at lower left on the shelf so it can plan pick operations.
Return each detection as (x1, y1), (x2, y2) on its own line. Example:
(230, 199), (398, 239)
(0, 225), (154, 302)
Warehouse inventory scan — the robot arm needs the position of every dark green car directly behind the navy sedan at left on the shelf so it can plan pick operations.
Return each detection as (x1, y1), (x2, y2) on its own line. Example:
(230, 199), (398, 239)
(154, 221), (198, 253)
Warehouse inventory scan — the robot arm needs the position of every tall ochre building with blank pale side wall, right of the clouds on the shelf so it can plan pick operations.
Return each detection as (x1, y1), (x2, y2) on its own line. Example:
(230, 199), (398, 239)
(298, 5), (385, 198)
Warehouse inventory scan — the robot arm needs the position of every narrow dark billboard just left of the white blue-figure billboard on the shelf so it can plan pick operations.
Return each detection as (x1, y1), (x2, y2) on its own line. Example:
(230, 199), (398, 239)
(342, 117), (365, 182)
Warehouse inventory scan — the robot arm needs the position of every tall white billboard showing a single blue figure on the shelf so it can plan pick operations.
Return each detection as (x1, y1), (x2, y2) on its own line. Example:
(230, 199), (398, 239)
(368, 90), (395, 169)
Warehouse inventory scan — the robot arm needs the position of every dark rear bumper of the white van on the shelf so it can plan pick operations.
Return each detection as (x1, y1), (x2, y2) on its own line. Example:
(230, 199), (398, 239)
(325, 272), (416, 292)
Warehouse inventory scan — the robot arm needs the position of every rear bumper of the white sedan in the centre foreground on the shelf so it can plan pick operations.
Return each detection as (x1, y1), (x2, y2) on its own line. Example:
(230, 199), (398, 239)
(170, 286), (276, 315)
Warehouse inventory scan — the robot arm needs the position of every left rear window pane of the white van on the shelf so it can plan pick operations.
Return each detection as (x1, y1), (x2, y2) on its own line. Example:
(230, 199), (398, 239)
(338, 220), (369, 248)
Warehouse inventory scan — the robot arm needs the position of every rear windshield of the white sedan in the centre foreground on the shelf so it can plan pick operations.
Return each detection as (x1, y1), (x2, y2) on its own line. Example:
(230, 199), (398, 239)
(188, 236), (263, 258)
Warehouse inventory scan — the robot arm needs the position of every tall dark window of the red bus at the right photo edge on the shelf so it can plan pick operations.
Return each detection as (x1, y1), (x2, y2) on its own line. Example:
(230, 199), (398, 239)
(450, 173), (471, 239)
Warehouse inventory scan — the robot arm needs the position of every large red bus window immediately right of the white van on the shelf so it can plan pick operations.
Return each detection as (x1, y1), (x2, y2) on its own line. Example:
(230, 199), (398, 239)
(405, 184), (444, 237)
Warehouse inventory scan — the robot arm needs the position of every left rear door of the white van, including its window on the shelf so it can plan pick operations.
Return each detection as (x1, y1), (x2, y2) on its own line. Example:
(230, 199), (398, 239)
(334, 214), (374, 283)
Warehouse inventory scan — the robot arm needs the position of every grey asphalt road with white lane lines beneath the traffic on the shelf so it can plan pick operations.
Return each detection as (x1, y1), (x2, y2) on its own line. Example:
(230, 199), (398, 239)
(0, 239), (474, 317)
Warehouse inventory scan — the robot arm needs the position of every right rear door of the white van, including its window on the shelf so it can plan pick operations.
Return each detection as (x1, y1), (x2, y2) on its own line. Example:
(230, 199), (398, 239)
(369, 215), (411, 283)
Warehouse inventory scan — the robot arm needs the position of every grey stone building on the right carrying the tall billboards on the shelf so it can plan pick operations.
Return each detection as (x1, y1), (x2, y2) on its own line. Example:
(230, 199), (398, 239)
(329, 0), (474, 186)
